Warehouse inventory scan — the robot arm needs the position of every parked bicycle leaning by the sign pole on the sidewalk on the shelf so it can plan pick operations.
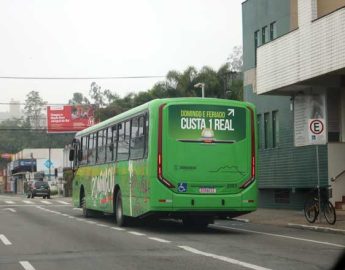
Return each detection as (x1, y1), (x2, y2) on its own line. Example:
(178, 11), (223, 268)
(304, 188), (337, 225)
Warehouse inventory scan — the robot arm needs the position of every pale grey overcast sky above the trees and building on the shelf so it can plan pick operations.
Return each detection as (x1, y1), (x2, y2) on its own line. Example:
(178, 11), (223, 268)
(0, 0), (243, 111)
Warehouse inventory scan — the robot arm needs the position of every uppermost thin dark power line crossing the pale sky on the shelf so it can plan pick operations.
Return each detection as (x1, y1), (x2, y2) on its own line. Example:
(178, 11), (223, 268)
(0, 75), (166, 80)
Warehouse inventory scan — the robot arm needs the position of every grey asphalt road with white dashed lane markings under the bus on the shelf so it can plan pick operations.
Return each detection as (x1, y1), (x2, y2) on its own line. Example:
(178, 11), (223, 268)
(0, 195), (345, 270)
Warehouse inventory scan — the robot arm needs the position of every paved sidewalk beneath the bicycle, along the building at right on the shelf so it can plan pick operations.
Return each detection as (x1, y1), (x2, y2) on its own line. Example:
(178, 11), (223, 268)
(232, 208), (345, 235)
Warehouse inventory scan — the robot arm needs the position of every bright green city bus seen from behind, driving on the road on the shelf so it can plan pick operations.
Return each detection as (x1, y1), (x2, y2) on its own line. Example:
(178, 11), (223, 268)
(70, 98), (257, 226)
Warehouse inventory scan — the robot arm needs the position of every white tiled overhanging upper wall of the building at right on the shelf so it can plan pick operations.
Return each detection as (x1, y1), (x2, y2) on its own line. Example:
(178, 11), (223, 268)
(256, 0), (345, 94)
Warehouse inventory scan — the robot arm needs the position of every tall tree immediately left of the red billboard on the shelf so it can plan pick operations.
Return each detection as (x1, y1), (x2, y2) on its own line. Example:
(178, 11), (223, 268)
(24, 91), (47, 129)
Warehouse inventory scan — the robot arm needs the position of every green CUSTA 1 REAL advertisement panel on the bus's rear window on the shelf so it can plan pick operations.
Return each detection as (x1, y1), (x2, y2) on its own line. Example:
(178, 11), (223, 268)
(169, 105), (246, 143)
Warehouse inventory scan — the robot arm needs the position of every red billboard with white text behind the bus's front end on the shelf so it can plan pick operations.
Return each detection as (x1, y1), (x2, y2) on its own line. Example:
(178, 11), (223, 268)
(47, 105), (95, 133)
